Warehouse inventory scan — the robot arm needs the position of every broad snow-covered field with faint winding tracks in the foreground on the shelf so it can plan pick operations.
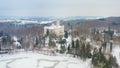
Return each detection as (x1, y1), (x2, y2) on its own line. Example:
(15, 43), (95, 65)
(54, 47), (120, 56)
(0, 52), (91, 68)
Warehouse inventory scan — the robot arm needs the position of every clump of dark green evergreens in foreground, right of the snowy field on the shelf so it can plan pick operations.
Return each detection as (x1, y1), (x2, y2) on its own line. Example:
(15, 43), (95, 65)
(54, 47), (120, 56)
(92, 48), (119, 68)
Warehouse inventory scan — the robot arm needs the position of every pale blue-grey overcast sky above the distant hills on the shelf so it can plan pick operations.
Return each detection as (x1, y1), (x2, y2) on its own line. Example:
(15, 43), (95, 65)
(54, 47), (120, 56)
(0, 0), (120, 17)
